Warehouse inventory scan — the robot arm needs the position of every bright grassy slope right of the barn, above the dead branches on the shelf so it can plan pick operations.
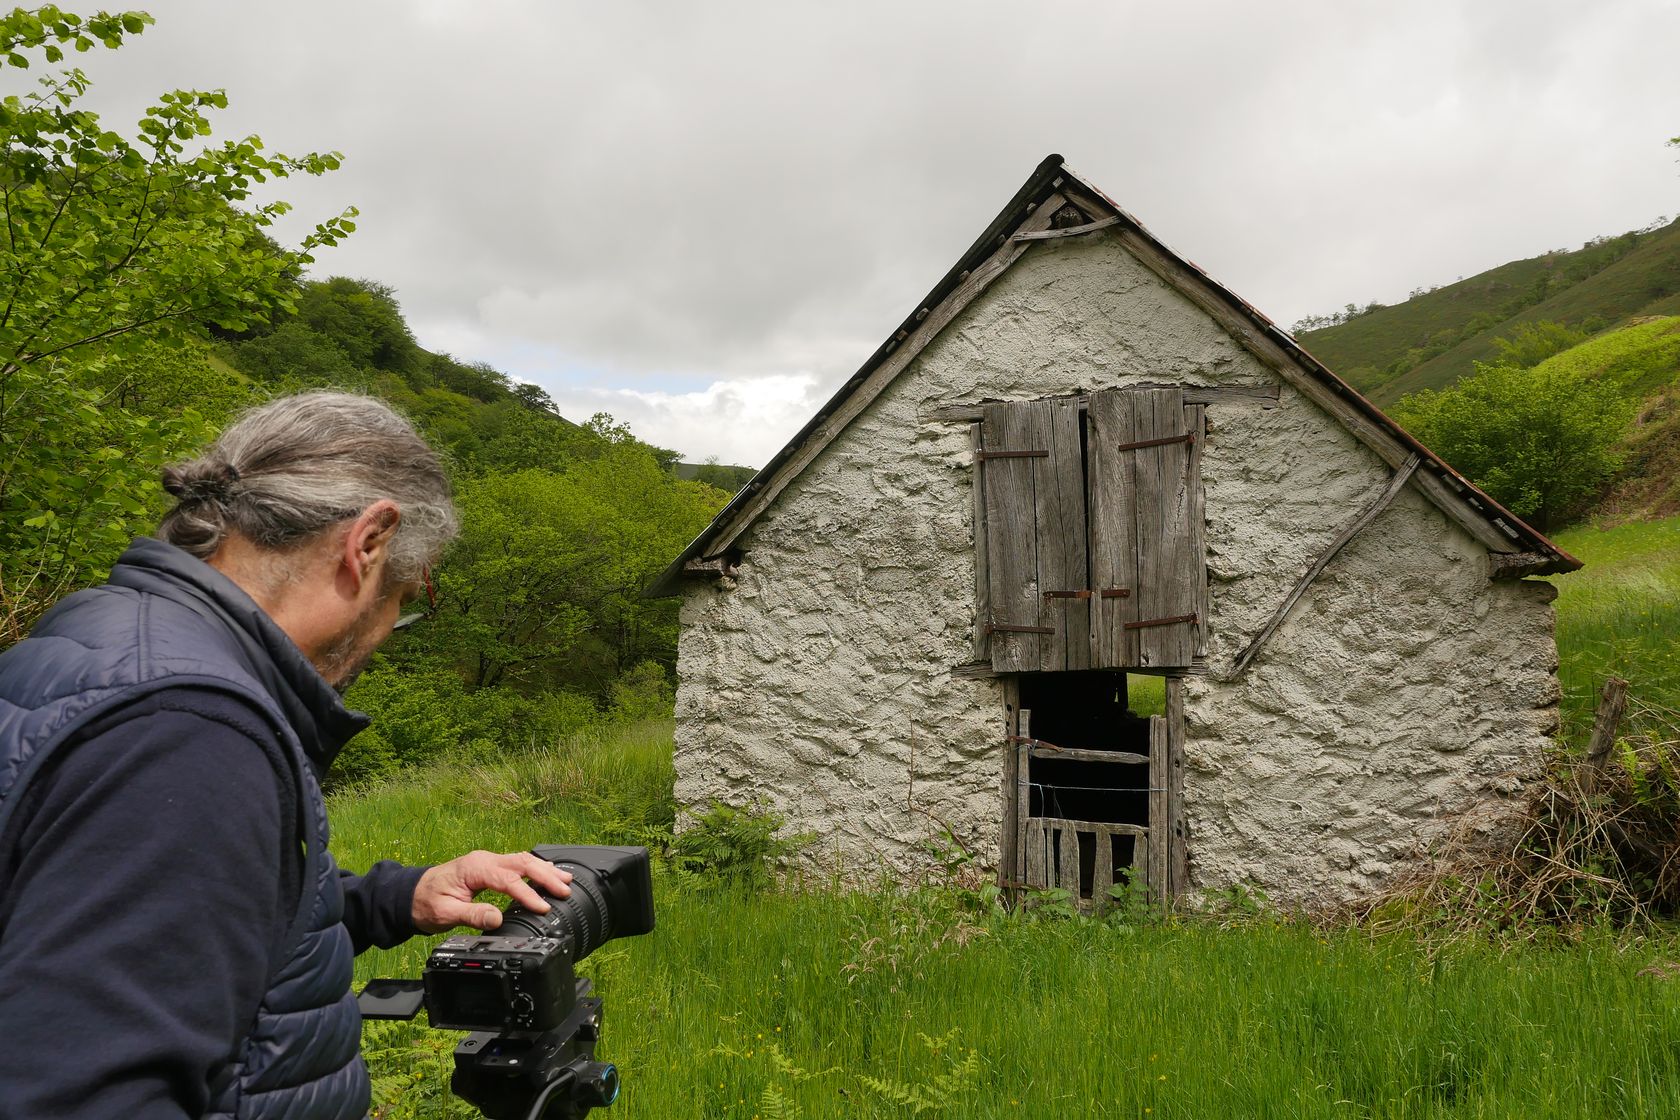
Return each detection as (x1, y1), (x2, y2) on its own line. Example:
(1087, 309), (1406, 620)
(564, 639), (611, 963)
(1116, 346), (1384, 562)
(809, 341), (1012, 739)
(1552, 517), (1680, 739)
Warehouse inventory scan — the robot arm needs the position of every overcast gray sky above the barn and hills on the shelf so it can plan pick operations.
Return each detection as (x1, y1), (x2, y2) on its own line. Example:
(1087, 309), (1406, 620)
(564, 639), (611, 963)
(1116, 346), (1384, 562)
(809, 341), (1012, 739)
(49, 0), (1680, 465)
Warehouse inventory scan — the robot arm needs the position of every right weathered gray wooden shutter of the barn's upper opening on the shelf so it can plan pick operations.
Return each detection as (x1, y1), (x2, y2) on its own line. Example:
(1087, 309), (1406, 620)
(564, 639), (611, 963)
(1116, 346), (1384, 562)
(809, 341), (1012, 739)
(1087, 388), (1208, 668)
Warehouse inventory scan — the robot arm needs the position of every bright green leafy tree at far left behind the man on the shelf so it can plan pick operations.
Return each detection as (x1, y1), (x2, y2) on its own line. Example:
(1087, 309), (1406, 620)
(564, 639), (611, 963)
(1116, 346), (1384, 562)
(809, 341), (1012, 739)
(0, 5), (354, 640)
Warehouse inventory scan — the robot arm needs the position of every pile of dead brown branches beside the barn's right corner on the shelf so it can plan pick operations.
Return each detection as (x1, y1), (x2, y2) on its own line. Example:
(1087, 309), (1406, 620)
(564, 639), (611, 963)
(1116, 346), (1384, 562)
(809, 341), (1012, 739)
(1352, 680), (1680, 940)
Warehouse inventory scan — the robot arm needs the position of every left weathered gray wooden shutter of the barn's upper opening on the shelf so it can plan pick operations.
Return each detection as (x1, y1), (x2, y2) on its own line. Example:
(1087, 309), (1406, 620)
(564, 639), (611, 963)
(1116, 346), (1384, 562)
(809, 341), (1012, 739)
(979, 398), (1090, 673)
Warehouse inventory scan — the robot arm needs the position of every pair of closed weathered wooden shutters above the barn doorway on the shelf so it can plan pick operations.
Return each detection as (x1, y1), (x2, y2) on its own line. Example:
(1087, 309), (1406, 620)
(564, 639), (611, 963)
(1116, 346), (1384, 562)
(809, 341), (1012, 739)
(974, 388), (1208, 673)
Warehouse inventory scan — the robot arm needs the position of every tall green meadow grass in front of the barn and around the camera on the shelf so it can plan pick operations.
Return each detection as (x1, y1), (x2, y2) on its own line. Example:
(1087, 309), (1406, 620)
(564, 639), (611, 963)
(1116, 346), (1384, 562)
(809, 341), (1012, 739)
(331, 724), (1680, 1120)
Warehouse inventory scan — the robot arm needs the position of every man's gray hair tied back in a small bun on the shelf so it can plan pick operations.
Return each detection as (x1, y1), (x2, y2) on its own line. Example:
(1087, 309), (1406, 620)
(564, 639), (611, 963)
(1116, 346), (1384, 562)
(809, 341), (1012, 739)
(158, 393), (457, 581)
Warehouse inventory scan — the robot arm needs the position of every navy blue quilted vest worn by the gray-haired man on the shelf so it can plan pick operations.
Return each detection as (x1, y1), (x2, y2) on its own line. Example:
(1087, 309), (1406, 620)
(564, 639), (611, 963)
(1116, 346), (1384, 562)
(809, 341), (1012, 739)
(0, 537), (370, 1120)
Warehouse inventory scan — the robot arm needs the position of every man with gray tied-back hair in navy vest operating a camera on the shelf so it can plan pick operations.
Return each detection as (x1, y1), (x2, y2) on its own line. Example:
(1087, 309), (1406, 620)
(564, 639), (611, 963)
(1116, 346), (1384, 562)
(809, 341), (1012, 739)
(0, 393), (570, 1120)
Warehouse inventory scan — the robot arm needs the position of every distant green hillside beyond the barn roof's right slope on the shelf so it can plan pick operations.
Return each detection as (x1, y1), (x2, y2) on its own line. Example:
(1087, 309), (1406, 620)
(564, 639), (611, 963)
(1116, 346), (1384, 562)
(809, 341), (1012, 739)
(1297, 220), (1680, 405)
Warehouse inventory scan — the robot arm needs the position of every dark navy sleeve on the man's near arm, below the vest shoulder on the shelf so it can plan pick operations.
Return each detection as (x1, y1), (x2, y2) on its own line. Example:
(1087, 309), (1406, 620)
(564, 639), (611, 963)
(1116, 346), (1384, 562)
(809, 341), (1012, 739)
(0, 693), (285, 1120)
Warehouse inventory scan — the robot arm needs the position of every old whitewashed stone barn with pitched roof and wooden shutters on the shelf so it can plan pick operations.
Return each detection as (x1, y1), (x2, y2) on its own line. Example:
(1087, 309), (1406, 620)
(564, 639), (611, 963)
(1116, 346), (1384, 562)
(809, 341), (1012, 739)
(650, 156), (1579, 905)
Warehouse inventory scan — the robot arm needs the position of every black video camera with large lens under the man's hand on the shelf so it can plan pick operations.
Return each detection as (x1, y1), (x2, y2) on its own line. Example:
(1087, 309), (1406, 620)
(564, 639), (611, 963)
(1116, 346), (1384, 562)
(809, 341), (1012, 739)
(358, 845), (654, 1120)
